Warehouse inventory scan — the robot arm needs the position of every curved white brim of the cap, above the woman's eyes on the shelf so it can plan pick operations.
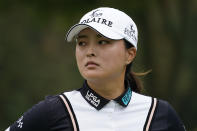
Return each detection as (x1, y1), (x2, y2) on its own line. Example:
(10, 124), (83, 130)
(66, 23), (124, 42)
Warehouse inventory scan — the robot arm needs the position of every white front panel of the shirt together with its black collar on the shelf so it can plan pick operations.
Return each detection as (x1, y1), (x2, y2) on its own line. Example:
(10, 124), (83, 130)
(64, 81), (152, 131)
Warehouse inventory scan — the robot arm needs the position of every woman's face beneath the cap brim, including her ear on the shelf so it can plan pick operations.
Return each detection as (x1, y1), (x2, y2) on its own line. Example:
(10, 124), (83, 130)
(76, 28), (136, 80)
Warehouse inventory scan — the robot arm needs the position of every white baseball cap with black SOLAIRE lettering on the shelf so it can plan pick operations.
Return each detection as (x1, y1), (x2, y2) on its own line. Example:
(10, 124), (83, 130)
(66, 7), (138, 49)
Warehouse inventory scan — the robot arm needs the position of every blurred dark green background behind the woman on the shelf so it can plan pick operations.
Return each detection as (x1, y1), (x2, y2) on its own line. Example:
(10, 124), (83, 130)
(0, 0), (197, 131)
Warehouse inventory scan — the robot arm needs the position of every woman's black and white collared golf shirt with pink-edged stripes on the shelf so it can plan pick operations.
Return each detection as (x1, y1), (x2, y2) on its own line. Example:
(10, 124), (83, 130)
(6, 81), (185, 131)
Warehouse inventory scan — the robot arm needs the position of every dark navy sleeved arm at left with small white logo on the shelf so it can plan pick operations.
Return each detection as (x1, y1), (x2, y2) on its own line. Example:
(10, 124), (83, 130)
(6, 96), (73, 131)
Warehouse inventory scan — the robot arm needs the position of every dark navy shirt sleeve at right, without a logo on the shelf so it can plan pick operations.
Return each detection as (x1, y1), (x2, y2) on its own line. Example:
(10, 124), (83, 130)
(151, 100), (185, 131)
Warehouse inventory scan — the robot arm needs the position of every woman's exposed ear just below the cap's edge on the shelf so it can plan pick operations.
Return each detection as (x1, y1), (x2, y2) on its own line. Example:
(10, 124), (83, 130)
(126, 47), (137, 65)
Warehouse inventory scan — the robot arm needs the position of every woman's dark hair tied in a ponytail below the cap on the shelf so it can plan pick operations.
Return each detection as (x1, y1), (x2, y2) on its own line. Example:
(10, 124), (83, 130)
(124, 39), (151, 93)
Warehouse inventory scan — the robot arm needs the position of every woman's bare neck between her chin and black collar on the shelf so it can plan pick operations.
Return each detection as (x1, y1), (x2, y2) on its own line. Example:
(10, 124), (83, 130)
(87, 77), (125, 100)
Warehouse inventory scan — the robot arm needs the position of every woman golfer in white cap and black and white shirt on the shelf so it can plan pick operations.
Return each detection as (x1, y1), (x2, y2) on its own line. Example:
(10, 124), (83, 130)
(7, 7), (185, 131)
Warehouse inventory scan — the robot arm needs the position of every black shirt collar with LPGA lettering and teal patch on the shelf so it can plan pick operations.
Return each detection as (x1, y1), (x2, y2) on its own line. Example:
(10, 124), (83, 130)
(80, 81), (132, 110)
